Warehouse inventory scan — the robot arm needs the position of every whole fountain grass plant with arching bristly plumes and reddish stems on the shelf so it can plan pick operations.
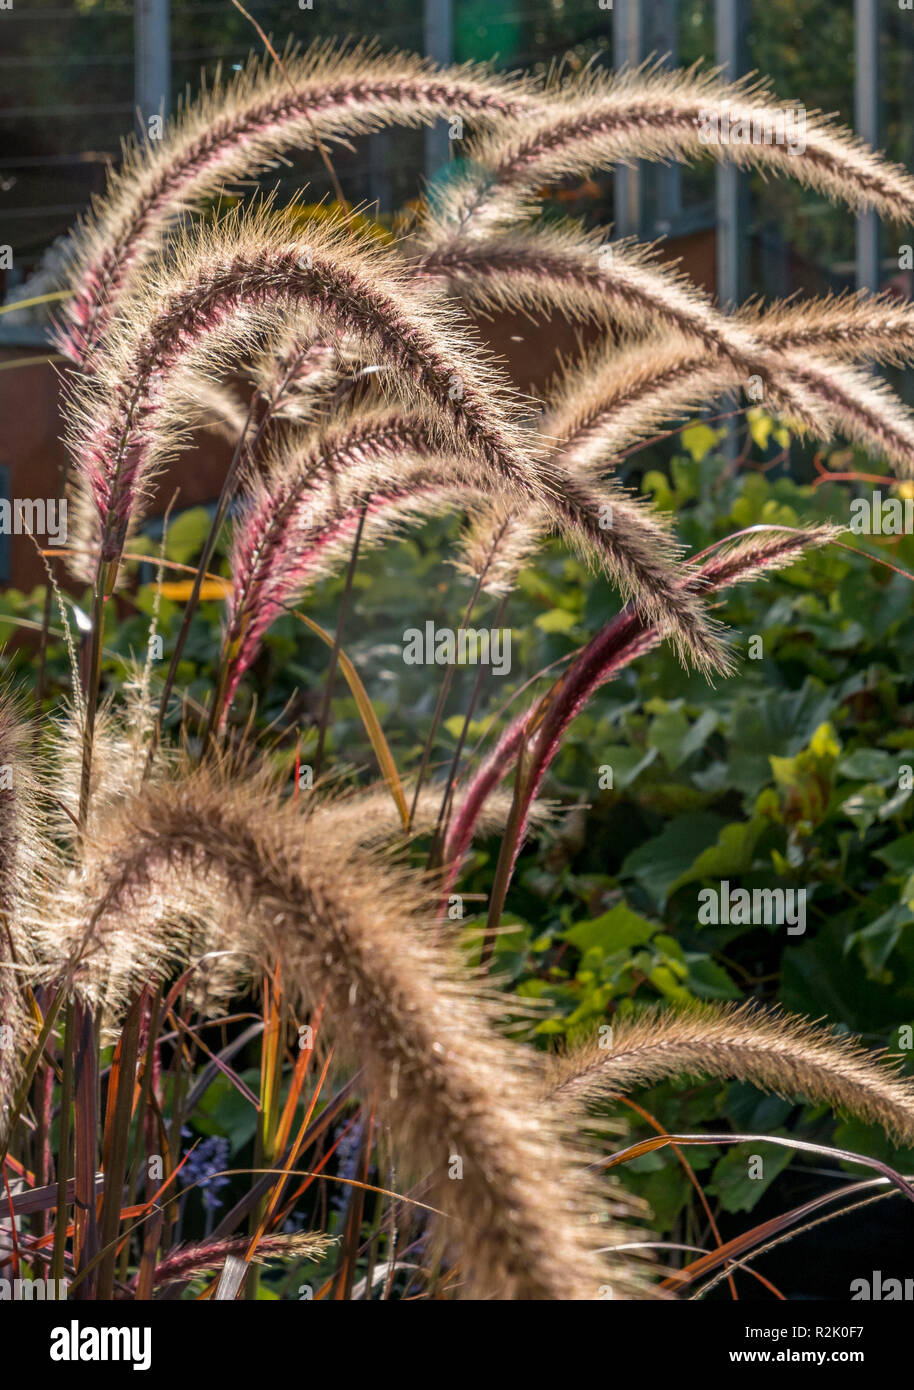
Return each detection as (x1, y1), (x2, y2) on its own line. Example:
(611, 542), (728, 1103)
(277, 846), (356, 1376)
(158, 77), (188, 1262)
(0, 46), (914, 1298)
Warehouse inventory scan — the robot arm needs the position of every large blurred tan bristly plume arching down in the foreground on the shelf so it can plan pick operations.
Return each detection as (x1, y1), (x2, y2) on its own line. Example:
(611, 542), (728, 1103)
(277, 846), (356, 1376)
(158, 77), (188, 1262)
(37, 771), (645, 1300)
